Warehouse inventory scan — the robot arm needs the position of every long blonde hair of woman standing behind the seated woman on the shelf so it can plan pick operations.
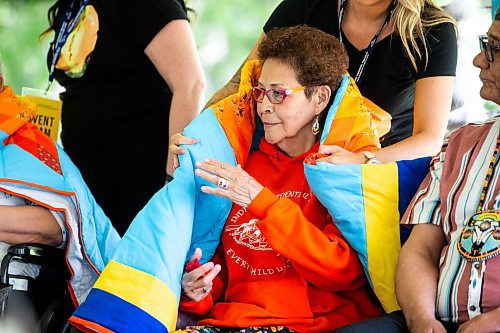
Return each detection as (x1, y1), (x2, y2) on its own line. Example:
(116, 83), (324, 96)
(393, 0), (458, 72)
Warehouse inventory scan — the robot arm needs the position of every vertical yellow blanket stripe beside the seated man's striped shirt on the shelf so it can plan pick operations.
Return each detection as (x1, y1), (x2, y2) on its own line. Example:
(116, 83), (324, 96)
(361, 163), (400, 313)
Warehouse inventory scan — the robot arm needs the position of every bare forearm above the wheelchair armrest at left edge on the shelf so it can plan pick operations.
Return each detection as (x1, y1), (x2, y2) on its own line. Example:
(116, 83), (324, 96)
(0, 206), (62, 246)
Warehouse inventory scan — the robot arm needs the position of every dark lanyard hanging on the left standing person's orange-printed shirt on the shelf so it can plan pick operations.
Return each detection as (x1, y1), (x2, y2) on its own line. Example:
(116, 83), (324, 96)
(47, 0), (89, 90)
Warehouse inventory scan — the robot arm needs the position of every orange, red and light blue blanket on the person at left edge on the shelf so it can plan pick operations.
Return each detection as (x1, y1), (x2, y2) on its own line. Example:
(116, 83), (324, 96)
(0, 87), (120, 305)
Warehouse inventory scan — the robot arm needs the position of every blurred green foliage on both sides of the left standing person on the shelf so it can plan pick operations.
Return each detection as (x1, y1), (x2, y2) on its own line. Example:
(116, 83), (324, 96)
(0, 0), (280, 99)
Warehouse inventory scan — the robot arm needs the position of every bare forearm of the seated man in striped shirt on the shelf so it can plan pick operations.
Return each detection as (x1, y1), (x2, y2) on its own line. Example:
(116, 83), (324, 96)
(396, 247), (439, 328)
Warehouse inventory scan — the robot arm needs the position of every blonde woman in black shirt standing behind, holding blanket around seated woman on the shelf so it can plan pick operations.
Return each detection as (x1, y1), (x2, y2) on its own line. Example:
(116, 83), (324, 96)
(170, 0), (457, 164)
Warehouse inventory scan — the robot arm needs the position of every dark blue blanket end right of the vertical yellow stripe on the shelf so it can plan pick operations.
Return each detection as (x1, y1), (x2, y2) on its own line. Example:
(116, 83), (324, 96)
(397, 157), (431, 245)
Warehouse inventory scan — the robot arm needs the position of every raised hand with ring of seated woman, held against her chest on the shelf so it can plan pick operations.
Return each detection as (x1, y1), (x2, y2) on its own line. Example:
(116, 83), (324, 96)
(195, 159), (264, 208)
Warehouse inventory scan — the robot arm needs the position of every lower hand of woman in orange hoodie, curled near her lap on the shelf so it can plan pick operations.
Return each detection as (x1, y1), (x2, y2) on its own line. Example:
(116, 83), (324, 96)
(181, 248), (221, 302)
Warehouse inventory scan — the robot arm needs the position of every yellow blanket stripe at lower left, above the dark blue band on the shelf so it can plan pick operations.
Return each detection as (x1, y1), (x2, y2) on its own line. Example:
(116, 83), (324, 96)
(94, 260), (178, 332)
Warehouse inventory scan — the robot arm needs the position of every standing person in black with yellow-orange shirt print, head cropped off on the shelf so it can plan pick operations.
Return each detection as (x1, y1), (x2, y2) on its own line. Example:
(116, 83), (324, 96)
(44, 0), (205, 235)
